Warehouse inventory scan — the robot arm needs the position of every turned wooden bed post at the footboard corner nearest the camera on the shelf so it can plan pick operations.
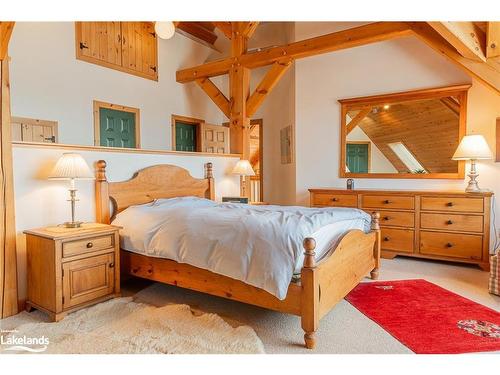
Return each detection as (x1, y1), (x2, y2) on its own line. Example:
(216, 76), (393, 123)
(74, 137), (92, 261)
(300, 237), (319, 349)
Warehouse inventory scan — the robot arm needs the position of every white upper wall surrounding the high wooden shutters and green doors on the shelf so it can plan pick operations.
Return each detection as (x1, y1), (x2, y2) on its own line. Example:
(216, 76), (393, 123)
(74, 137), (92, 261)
(9, 22), (222, 150)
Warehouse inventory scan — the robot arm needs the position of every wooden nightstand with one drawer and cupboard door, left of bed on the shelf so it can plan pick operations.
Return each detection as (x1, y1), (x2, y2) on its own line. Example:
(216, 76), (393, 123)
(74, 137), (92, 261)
(24, 223), (120, 321)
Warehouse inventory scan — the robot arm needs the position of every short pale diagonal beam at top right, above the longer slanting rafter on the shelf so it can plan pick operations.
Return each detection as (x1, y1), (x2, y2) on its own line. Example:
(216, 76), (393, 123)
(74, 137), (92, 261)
(429, 22), (486, 61)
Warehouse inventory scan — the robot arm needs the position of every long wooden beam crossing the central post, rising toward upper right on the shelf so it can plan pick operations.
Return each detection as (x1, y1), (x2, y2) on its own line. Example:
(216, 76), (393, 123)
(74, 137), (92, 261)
(176, 22), (412, 83)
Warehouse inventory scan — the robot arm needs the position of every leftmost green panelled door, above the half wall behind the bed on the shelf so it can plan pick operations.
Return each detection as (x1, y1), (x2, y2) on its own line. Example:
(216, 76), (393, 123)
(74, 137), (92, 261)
(99, 108), (136, 148)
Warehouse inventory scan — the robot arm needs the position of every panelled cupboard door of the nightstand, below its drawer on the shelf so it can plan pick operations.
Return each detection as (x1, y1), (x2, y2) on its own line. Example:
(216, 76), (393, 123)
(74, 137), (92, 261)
(62, 253), (115, 309)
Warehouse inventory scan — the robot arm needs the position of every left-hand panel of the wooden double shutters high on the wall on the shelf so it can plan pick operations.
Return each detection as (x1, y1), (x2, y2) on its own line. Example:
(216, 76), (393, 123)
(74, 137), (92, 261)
(75, 22), (122, 66)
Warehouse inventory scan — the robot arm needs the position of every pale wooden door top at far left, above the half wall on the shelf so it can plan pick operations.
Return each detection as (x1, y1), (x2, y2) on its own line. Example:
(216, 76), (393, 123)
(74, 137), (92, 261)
(11, 117), (58, 143)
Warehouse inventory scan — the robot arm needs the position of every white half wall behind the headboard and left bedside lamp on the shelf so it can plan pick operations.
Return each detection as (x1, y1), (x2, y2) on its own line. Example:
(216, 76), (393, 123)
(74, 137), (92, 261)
(13, 145), (239, 299)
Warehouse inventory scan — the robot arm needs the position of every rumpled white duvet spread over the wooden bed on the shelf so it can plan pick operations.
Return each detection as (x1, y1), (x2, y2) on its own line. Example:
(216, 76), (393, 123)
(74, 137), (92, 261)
(113, 197), (371, 299)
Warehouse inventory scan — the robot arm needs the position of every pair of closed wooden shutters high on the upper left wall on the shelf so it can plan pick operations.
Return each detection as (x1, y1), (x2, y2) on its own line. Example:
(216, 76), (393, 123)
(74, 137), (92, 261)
(75, 22), (158, 81)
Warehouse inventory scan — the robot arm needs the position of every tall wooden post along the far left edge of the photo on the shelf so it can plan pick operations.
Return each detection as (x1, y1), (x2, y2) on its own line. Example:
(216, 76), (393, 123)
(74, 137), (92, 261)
(0, 57), (18, 318)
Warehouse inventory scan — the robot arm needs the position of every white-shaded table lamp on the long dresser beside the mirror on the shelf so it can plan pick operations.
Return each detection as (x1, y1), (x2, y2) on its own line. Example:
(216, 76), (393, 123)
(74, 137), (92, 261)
(452, 134), (493, 193)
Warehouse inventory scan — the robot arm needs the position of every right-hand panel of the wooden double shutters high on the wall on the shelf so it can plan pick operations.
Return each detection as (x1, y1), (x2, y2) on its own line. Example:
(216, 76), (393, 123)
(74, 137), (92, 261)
(122, 22), (158, 79)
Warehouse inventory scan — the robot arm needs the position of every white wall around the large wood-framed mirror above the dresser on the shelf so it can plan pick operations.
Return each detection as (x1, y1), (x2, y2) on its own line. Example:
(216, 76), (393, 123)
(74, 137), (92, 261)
(295, 22), (500, 244)
